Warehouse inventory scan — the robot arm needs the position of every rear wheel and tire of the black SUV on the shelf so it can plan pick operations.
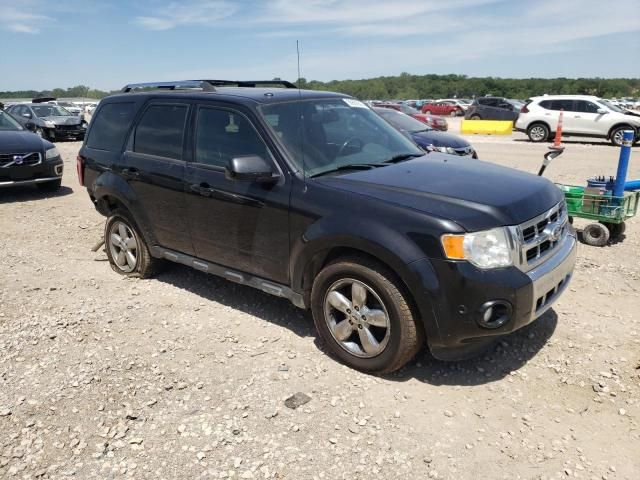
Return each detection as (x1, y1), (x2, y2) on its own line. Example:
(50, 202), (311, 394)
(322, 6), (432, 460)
(104, 209), (161, 278)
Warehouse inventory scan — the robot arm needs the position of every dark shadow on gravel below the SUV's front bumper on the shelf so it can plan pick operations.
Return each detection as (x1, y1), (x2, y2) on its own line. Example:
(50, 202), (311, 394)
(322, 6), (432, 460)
(386, 309), (558, 386)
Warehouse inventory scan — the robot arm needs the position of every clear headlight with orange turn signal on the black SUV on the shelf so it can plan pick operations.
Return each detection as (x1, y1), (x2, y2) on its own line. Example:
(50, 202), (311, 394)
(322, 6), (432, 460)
(442, 228), (513, 270)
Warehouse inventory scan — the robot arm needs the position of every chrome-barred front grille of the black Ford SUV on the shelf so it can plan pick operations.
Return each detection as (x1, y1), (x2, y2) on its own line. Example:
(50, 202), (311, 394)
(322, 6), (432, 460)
(513, 201), (570, 271)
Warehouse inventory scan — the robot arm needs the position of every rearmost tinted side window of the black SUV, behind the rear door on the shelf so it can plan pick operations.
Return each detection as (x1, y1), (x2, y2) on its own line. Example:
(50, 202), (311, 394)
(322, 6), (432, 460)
(87, 102), (134, 151)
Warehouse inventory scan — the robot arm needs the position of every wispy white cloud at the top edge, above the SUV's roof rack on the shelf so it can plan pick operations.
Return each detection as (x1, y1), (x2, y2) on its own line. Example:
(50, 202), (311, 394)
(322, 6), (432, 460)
(135, 0), (237, 30)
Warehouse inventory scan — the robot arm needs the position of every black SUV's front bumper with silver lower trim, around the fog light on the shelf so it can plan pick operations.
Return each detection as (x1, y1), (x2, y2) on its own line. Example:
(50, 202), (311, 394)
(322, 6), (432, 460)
(423, 231), (577, 360)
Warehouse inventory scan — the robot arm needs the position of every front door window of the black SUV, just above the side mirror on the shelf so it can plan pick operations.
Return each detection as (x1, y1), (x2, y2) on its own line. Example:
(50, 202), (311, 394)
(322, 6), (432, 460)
(195, 108), (268, 167)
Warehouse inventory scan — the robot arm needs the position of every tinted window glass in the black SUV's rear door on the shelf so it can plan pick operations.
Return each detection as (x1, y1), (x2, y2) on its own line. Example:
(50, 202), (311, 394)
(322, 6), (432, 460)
(133, 105), (187, 160)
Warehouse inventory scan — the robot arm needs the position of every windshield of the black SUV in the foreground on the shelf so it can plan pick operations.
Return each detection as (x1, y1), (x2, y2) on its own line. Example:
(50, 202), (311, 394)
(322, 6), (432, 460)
(261, 98), (424, 176)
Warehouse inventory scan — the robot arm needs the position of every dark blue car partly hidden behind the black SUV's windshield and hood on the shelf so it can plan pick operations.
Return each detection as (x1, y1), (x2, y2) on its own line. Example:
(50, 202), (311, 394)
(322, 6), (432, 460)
(373, 108), (478, 158)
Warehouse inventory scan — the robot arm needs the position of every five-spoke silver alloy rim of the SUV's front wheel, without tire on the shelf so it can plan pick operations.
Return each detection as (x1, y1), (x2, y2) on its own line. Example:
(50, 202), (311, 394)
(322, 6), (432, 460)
(324, 278), (391, 358)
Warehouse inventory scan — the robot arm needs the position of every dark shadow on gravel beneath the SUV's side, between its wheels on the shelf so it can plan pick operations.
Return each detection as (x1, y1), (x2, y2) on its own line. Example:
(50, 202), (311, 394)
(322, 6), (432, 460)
(155, 264), (315, 337)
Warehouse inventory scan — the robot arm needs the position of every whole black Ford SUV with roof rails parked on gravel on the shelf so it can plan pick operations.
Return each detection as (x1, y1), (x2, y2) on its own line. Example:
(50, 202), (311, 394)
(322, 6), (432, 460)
(78, 80), (576, 373)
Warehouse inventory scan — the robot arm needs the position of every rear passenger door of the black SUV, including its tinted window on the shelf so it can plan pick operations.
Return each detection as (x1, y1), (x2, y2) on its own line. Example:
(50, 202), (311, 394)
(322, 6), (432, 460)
(118, 99), (193, 254)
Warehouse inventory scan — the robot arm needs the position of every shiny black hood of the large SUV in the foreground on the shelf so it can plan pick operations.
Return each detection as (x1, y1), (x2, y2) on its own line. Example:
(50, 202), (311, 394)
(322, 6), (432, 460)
(315, 153), (564, 231)
